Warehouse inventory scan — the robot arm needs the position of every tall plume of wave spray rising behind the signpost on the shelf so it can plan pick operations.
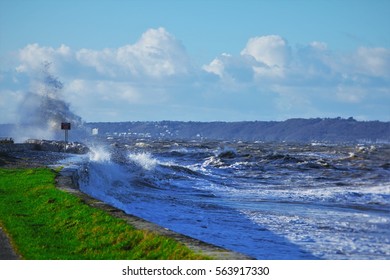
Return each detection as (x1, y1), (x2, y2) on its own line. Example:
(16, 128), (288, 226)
(13, 62), (86, 141)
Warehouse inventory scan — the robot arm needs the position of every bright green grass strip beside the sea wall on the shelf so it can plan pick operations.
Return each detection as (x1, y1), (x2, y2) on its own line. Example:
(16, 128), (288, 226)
(0, 168), (207, 260)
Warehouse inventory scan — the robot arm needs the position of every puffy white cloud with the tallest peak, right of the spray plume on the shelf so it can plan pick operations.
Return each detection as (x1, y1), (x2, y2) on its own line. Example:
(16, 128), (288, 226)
(76, 28), (190, 78)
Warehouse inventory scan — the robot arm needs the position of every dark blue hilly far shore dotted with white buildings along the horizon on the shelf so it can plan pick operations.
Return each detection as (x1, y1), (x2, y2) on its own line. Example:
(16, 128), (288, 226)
(0, 118), (390, 143)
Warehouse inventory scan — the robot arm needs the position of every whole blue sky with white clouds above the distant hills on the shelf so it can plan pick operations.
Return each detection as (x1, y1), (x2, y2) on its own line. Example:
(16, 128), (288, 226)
(0, 0), (390, 123)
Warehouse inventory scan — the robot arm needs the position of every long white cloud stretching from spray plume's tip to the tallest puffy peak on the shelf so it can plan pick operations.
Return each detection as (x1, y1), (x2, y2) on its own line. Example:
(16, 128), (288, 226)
(16, 28), (191, 80)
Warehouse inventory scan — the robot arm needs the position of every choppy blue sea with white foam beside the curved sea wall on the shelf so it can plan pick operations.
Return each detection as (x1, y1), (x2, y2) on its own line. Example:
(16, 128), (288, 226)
(69, 139), (390, 259)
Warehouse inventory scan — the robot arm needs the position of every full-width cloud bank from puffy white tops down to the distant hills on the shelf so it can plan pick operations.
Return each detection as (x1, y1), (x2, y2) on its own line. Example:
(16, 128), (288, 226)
(0, 28), (390, 123)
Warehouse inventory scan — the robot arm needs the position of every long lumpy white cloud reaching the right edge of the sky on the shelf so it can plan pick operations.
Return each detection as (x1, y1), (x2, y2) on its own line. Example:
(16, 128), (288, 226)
(203, 35), (390, 89)
